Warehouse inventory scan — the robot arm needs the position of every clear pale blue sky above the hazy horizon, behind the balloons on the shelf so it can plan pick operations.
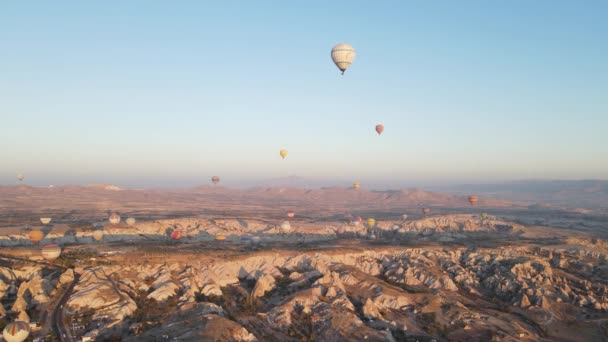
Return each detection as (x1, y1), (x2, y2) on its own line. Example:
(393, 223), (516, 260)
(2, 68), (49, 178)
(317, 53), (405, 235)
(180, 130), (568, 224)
(0, 0), (608, 186)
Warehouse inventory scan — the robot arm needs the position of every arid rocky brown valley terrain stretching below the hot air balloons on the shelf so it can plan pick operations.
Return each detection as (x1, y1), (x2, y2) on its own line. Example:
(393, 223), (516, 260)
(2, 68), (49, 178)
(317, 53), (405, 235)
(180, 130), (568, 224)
(0, 186), (608, 341)
